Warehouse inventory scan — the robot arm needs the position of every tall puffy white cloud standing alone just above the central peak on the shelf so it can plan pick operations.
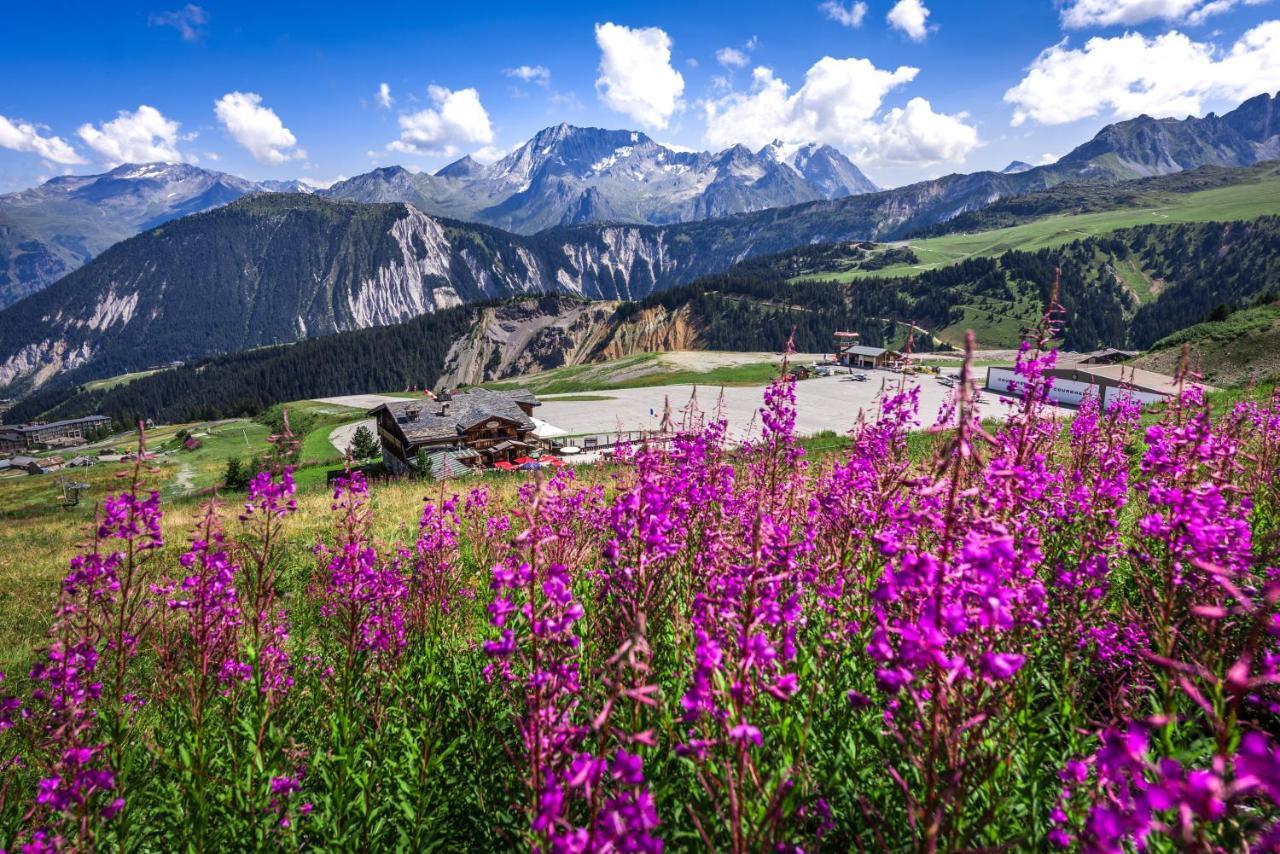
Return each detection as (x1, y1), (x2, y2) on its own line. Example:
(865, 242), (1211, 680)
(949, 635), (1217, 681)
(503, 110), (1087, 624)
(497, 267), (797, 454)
(595, 23), (685, 129)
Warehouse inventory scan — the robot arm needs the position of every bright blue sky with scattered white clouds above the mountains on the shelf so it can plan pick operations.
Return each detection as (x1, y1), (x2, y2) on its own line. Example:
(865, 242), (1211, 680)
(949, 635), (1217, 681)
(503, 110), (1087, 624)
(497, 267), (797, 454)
(0, 0), (1280, 191)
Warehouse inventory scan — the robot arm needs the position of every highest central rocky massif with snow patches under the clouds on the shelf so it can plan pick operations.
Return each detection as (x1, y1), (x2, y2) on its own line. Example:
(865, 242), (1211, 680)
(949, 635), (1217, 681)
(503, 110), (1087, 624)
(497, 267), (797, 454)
(321, 124), (877, 234)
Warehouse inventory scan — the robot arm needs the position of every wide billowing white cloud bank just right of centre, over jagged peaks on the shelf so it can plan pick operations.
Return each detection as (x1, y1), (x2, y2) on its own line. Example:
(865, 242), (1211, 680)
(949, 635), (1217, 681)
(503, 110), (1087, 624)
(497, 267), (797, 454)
(703, 56), (978, 164)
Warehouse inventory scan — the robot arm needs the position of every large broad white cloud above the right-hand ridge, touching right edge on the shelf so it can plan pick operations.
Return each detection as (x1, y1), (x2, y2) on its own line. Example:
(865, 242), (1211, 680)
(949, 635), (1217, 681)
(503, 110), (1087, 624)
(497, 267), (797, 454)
(1005, 20), (1280, 125)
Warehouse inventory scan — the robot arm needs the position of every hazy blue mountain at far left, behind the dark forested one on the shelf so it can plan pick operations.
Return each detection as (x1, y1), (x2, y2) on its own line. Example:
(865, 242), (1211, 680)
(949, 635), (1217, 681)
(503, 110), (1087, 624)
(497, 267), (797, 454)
(0, 163), (303, 307)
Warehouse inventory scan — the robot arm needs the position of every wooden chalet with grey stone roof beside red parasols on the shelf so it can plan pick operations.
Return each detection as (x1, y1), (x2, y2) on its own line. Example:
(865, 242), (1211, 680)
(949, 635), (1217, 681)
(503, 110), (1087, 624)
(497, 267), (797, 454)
(369, 388), (539, 478)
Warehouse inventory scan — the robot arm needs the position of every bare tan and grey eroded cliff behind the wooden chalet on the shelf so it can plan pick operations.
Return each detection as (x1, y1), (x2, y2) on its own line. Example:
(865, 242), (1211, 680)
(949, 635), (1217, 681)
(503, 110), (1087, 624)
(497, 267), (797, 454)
(439, 297), (699, 387)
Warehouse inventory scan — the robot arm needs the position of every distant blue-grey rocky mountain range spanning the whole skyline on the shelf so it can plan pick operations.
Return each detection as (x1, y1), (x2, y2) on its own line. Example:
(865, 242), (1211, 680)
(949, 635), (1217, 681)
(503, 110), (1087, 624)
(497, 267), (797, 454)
(0, 95), (1280, 307)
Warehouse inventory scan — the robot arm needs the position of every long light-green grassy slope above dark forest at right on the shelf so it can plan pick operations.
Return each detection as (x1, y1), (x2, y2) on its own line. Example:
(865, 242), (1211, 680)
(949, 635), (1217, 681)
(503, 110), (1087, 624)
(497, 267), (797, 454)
(801, 174), (1280, 281)
